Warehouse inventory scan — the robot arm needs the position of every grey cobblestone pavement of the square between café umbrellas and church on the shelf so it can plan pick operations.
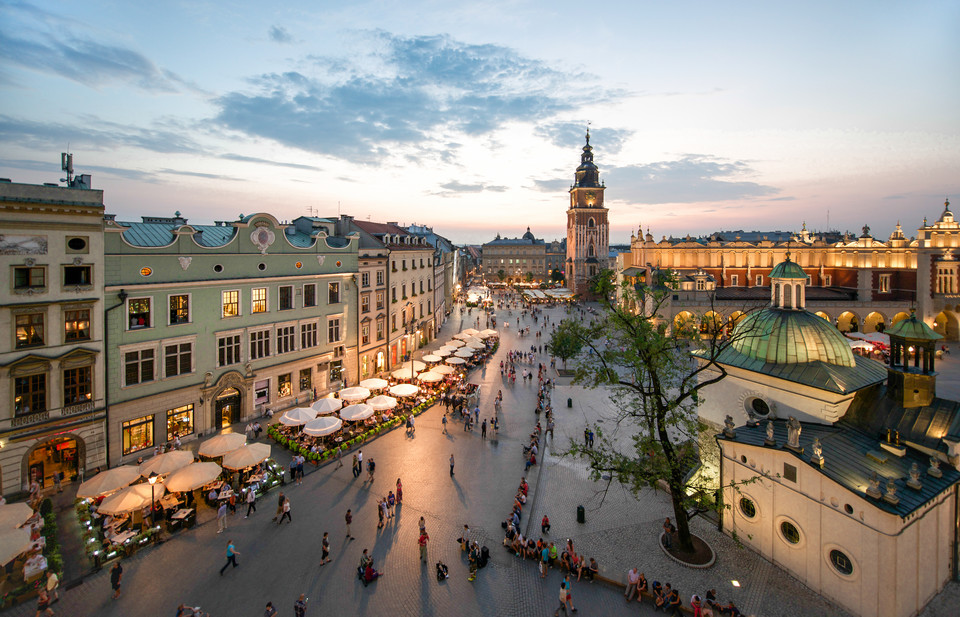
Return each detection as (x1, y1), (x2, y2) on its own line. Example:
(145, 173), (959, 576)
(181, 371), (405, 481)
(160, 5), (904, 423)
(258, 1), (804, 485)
(15, 309), (960, 617)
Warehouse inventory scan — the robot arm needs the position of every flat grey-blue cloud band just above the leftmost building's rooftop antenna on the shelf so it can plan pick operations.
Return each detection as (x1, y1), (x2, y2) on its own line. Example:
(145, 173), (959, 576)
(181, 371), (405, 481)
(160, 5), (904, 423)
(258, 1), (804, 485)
(0, 115), (202, 154)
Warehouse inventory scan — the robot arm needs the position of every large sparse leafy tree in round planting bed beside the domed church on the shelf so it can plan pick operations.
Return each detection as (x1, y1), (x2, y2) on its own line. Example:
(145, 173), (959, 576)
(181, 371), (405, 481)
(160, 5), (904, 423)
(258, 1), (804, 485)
(548, 271), (760, 552)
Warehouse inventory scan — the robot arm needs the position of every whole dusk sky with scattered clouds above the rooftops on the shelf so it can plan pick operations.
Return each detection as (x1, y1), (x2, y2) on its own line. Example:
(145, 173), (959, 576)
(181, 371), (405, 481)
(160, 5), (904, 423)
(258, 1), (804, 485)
(0, 0), (960, 243)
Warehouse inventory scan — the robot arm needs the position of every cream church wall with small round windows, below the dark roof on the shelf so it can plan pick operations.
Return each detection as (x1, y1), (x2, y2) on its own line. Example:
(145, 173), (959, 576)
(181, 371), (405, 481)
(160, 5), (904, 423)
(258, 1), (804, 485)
(720, 440), (953, 617)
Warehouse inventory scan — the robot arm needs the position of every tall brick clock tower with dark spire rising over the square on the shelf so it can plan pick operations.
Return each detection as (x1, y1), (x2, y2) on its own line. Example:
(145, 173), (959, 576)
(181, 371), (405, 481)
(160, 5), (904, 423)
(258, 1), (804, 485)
(564, 130), (610, 297)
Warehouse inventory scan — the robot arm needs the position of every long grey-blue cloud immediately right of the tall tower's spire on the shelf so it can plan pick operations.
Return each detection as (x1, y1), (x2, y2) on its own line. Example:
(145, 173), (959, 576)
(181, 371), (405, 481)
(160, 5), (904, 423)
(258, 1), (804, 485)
(604, 154), (780, 204)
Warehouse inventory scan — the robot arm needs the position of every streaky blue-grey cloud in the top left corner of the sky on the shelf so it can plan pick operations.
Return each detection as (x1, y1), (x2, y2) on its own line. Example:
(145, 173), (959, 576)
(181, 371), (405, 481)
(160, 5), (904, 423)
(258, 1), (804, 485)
(0, 13), (197, 92)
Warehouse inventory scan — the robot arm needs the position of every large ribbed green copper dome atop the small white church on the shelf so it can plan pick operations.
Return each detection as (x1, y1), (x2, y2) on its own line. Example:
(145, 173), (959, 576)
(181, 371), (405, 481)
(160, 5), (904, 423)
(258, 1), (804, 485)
(730, 308), (855, 366)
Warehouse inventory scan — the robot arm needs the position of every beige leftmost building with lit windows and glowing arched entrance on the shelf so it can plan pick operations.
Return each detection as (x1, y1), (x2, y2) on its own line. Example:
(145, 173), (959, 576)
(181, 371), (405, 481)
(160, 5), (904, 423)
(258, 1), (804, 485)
(0, 180), (107, 495)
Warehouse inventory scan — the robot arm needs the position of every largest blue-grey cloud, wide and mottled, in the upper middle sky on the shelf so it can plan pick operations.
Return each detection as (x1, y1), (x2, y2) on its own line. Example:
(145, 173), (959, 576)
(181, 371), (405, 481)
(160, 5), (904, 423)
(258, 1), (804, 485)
(215, 32), (603, 163)
